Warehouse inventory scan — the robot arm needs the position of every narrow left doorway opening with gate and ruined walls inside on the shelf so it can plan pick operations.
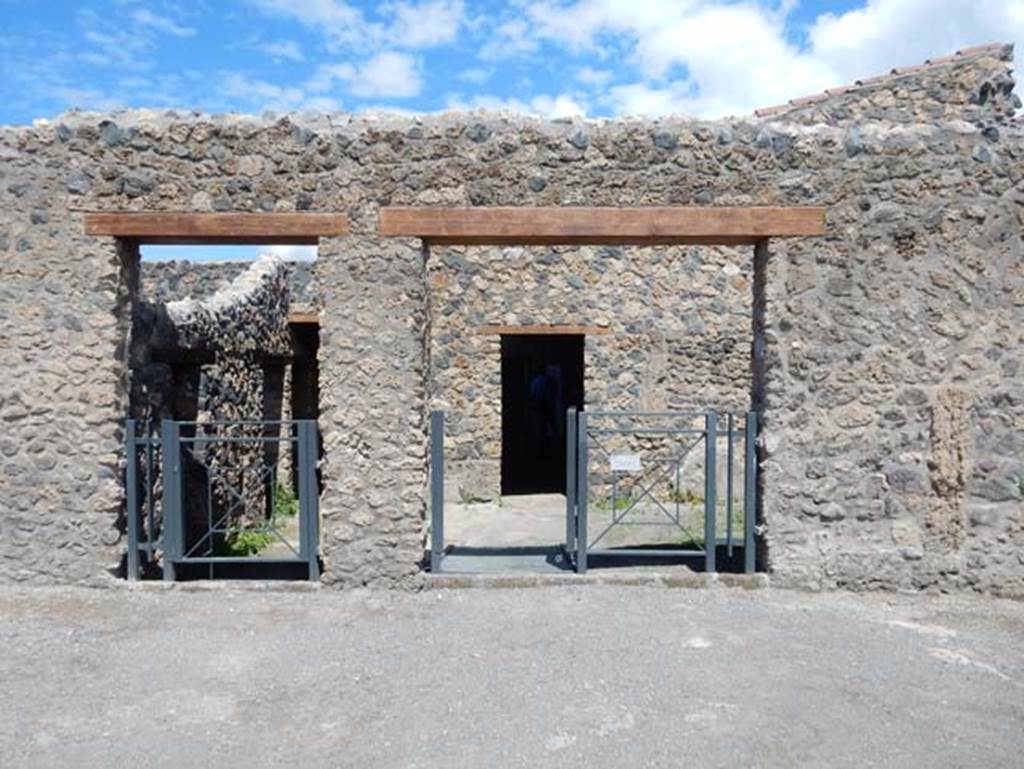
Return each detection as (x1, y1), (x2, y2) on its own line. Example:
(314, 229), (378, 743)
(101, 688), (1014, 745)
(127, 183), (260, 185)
(125, 244), (322, 580)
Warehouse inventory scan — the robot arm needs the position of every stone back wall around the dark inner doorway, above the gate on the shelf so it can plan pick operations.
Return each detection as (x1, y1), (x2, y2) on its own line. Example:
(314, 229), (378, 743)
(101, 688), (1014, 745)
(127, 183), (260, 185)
(428, 243), (753, 500)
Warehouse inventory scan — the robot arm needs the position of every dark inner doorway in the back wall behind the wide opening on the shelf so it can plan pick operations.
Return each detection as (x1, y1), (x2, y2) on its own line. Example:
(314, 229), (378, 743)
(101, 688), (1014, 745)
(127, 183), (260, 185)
(502, 335), (584, 495)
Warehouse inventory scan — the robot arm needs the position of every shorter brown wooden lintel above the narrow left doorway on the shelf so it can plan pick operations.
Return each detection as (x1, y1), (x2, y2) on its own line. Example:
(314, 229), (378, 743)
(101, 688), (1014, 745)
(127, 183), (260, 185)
(85, 212), (348, 246)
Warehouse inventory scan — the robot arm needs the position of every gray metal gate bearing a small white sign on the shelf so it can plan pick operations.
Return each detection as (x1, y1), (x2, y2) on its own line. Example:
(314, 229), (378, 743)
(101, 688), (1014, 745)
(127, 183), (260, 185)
(565, 409), (758, 572)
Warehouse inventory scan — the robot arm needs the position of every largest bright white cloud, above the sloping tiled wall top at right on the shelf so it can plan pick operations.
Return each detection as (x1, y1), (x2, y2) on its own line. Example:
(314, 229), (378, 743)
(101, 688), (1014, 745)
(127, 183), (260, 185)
(516, 0), (1024, 117)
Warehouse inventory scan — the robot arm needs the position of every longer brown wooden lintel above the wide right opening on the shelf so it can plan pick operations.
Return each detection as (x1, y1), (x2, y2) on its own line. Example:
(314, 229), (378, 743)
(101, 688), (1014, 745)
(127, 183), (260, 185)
(379, 206), (825, 246)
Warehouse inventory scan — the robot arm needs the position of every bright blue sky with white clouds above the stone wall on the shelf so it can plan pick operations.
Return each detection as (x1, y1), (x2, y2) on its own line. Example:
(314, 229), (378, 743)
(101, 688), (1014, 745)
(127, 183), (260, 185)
(0, 0), (1024, 262)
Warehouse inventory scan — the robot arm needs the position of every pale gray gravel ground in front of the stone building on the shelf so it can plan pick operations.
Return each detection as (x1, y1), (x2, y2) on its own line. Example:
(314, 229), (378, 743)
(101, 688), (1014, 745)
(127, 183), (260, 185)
(0, 585), (1024, 768)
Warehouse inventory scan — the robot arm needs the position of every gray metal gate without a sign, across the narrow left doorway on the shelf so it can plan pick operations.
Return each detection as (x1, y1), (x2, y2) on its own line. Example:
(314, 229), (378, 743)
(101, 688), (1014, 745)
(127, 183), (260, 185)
(125, 420), (319, 581)
